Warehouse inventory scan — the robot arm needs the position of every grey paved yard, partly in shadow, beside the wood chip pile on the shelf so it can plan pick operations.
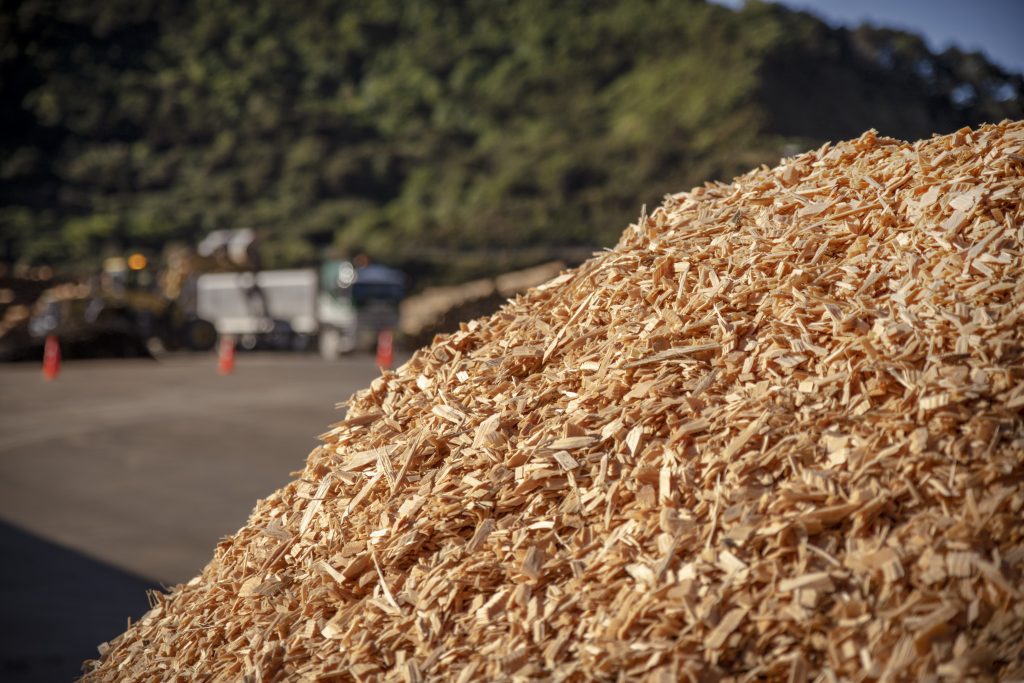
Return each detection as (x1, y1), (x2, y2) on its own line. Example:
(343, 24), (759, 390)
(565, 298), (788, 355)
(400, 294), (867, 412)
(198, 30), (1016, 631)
(0, 353), (395, 680)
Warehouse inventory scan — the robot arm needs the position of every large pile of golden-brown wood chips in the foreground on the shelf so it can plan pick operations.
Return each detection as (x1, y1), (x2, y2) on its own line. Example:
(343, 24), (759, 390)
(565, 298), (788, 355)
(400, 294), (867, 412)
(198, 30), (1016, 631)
(81, 122), (1024, 681)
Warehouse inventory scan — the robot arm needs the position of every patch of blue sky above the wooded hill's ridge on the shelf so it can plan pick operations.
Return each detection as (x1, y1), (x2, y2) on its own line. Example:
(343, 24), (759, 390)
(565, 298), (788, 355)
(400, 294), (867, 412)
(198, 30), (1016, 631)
(717, 0), (1024, 73)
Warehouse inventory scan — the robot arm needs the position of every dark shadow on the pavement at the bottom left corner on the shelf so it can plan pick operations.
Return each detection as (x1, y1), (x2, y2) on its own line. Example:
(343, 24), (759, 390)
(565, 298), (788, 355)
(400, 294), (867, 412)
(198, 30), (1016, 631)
(0, 521), (159, 683)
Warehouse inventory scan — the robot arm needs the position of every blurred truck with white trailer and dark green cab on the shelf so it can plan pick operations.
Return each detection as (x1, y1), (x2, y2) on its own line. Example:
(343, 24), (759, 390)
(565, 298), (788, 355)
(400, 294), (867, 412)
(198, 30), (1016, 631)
(196, 260), (406, 359)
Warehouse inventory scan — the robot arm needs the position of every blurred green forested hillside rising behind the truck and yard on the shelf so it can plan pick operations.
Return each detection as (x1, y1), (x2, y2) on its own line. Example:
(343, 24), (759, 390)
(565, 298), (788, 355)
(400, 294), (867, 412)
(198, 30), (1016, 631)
(0, 0), (1024, 280)
